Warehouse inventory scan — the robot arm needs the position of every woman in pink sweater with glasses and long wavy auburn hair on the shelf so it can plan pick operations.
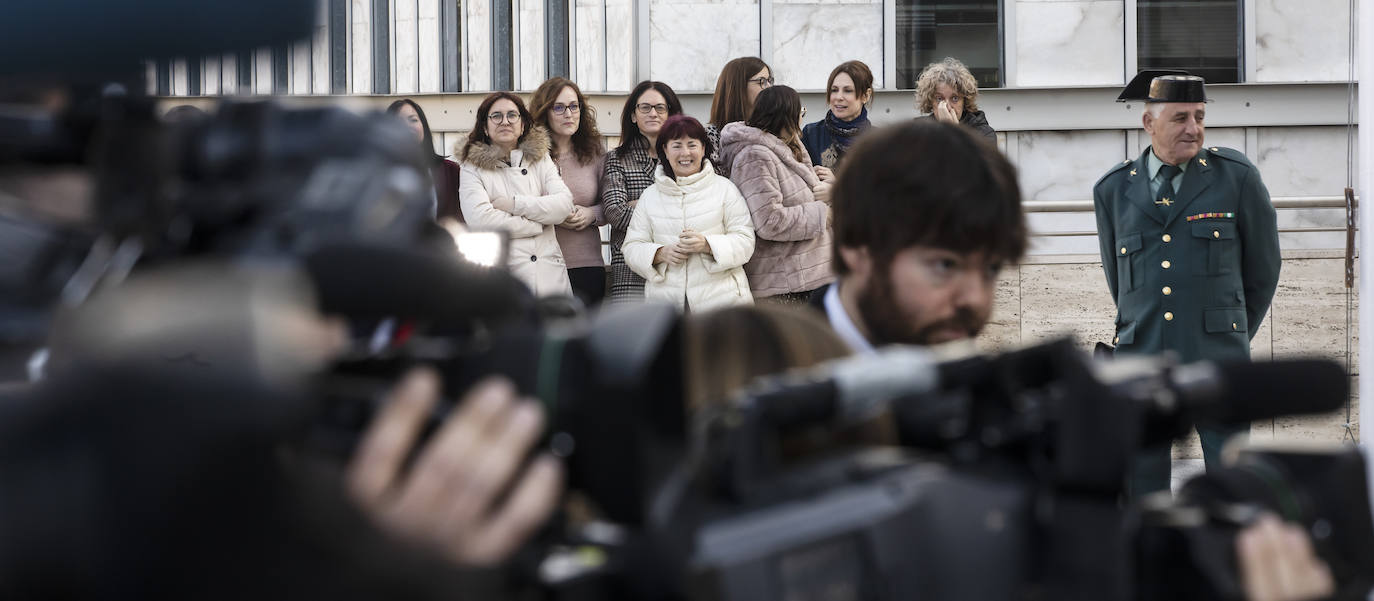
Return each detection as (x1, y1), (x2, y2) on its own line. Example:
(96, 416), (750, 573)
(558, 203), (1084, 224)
(529, 77), (606, 307)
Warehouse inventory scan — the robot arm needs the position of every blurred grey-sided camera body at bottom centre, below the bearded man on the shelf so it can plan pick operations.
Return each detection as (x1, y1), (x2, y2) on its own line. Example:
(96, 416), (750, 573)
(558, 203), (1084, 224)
(688, 450), (1035, 601)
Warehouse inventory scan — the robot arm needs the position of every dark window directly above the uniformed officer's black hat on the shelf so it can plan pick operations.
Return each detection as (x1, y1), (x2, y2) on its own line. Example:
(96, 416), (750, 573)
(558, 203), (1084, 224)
(1136, 0), (1243, 84)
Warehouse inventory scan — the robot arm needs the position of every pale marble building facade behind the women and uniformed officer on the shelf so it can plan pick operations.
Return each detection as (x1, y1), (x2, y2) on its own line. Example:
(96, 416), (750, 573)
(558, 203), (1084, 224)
(158, 0), (1358, 452)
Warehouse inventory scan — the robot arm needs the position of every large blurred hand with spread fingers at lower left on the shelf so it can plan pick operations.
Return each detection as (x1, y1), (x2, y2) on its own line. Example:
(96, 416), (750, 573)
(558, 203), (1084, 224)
(348, 369), (563, 565)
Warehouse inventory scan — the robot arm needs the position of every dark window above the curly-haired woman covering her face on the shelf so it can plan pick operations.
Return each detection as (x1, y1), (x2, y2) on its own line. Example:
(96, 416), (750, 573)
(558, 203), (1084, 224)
(896, 0), (1002, 88)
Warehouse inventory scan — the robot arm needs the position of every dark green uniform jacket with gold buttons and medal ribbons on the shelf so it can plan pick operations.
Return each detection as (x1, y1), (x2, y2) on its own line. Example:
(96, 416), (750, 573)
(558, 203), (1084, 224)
(1092, 147), (1279, 362)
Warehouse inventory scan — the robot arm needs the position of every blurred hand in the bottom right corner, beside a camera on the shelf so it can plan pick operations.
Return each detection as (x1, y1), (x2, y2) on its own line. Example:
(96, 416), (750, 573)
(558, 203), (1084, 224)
(1235, 514), (1336, 601)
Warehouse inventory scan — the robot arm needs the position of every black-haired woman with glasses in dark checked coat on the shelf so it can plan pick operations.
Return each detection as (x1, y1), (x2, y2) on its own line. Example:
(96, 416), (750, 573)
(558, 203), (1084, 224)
(602, 81), (683, 303)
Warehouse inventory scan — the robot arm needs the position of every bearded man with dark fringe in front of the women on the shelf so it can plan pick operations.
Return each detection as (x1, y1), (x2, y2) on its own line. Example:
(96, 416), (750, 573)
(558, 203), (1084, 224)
(812, 120), (1028, 352)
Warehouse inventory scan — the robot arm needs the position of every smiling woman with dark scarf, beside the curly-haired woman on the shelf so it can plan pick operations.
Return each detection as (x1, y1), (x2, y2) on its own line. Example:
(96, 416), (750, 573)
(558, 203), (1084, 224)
(801, 61), (872, 171)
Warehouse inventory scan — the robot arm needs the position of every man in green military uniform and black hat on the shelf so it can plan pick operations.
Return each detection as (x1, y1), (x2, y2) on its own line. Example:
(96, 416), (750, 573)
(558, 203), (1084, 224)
(1092, 72), (1279, 496)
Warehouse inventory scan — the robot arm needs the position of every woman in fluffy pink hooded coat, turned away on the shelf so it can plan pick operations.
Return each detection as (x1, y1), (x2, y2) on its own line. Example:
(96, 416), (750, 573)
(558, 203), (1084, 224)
(720, 85), (834, 305)
